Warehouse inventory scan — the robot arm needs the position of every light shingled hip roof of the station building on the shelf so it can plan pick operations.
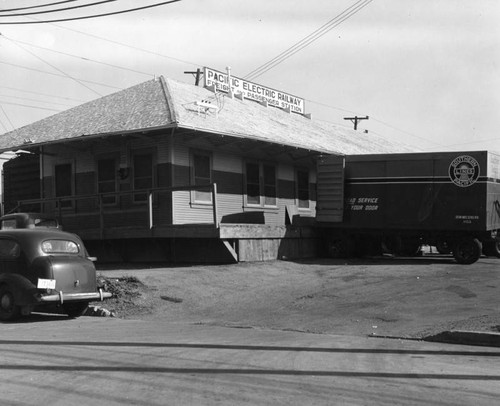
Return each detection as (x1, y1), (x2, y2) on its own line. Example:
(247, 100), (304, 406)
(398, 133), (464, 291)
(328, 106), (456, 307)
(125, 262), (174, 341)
(0, 77), (411, 154)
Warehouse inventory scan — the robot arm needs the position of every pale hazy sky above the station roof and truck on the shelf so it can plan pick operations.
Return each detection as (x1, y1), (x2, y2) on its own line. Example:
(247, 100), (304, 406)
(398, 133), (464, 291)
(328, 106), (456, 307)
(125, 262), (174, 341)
(0, 0), (500, 152)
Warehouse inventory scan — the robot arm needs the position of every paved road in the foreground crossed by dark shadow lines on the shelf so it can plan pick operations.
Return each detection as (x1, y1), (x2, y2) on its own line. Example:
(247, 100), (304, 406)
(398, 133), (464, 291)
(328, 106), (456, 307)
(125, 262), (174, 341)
(0, 316), (500, 406)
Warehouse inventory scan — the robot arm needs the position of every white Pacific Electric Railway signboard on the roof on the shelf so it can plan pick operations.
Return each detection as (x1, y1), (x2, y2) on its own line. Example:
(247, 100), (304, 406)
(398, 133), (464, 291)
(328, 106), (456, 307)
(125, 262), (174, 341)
(204, 68), (305, 114)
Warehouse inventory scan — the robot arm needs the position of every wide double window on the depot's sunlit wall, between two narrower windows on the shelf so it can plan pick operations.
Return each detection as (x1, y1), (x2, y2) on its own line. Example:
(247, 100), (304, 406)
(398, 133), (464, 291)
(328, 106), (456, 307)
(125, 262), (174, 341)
(246, 162), (277, 207)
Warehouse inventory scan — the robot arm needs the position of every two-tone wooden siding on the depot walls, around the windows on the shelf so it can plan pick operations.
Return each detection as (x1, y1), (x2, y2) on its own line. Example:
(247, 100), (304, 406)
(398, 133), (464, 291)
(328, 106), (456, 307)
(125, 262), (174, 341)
(34, 133), (316, 232)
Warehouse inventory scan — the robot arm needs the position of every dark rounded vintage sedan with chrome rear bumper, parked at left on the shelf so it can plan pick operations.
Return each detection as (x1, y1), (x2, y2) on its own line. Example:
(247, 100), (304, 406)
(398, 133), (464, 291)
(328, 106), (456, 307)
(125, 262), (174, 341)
(0, 228), (111, 321)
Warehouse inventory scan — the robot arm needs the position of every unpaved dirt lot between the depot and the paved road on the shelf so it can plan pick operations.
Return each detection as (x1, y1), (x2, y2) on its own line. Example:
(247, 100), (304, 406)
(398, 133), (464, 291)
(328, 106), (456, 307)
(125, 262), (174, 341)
(94, 255), (500, 338)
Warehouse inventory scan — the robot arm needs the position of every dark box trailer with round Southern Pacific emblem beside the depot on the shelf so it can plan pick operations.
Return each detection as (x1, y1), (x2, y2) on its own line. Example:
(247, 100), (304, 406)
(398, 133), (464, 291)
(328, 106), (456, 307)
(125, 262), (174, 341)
(316, 151), (500, 264)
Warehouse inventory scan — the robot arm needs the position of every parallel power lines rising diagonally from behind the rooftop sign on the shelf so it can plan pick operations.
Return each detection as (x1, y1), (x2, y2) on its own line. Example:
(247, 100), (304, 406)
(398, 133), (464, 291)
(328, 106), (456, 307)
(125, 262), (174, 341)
(245, 0), (373, 80)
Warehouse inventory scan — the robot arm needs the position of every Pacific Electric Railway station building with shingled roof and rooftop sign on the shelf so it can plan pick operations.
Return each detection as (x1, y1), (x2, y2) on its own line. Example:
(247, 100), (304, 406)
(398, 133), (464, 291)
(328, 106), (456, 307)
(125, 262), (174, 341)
(0, 68), (408, 262)
